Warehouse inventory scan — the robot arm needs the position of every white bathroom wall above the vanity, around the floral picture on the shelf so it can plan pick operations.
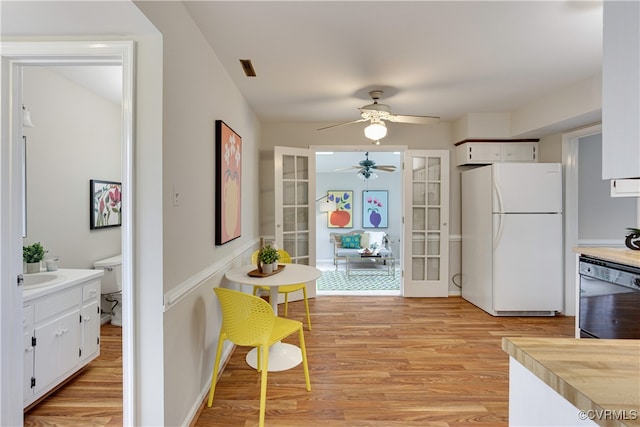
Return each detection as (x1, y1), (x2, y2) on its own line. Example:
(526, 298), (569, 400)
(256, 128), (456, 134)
(23, 66), (122, 268)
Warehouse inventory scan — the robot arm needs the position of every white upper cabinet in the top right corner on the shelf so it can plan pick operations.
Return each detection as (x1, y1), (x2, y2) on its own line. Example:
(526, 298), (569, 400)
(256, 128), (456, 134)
(602, 1), (640, 179)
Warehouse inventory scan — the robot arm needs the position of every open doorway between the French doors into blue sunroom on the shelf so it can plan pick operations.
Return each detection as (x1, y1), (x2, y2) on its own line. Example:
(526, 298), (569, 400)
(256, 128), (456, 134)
(315, 146), (403, 296)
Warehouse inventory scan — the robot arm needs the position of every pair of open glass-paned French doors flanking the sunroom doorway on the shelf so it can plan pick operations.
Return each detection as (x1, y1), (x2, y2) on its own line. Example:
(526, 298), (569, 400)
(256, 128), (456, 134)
(274, 147), (449, 297)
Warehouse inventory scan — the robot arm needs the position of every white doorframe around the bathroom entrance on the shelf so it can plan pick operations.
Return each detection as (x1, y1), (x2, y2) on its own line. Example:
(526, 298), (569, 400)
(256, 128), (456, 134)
(0, 41), (136, 425)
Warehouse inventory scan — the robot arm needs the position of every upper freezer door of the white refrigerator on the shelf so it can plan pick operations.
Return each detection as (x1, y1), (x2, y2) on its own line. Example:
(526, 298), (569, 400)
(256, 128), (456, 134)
(492, 163), (562, 213)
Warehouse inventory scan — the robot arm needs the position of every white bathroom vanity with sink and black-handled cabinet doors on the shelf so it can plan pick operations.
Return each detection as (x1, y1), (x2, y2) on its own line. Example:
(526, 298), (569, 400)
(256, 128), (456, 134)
(22, 269), (104, 409)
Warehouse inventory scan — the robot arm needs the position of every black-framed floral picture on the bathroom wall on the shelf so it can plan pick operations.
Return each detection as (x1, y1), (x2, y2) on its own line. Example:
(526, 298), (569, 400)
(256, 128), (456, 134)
(89, 179), (122, 230)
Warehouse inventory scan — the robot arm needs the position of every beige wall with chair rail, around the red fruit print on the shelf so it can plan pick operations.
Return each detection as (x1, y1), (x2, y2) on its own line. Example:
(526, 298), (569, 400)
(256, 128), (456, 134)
(132, 2), (260, 425)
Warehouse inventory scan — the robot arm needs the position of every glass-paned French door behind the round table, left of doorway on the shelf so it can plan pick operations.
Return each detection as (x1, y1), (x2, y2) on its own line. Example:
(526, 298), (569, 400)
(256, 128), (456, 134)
(274, 147), (316, 300)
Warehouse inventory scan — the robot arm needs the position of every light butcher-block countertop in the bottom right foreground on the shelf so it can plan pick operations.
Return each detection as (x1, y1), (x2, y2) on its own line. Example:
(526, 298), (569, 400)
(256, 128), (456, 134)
(502, 337), (640, 426)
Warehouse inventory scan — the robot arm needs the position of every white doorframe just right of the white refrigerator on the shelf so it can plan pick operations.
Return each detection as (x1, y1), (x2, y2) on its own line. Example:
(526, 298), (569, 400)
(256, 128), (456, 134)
(562, 124), (602, 316)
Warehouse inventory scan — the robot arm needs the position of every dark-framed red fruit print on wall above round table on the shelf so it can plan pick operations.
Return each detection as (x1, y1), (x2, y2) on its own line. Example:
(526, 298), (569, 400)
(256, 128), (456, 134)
(215, 120), (242, 245)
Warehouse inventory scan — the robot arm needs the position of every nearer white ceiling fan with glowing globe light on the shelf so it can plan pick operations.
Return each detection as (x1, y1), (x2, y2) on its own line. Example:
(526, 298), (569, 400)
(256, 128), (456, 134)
(318, 90), (440, 141)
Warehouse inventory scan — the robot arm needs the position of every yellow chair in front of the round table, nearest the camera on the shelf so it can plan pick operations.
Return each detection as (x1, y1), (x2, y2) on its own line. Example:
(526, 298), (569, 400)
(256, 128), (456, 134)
(207, 288), (311, 427)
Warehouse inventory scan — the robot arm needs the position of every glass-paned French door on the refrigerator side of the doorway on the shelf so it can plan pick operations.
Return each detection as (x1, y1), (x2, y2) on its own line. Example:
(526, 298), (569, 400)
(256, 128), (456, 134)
(402, 150), (449, 297)
